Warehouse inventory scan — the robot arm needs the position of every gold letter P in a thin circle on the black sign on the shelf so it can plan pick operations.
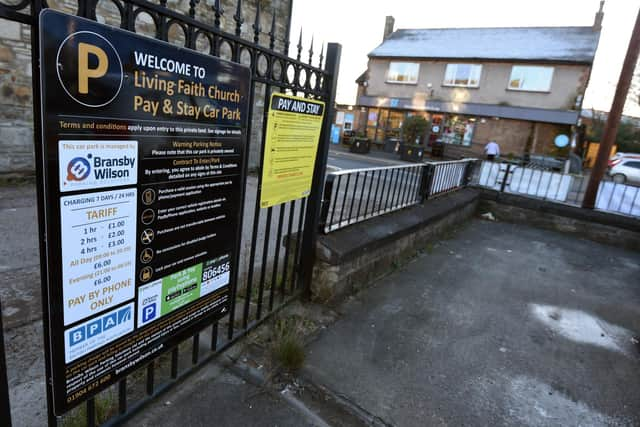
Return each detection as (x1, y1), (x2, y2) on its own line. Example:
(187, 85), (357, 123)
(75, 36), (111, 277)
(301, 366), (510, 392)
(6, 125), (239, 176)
(56, 31), (124, 107)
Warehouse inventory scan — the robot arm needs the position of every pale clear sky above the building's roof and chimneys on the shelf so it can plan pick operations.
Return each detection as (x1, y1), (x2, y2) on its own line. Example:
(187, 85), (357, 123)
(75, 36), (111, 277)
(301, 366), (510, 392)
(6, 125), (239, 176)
(291, 0), (640, 116)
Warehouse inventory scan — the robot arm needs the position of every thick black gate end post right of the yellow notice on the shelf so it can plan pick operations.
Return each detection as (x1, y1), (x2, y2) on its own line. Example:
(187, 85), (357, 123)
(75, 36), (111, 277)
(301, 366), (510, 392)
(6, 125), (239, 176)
(301, 43), (342, 299)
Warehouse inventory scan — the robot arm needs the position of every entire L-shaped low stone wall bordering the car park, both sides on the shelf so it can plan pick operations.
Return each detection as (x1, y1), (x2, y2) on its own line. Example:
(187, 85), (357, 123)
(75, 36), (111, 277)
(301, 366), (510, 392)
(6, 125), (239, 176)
(311, 188), (640, 303)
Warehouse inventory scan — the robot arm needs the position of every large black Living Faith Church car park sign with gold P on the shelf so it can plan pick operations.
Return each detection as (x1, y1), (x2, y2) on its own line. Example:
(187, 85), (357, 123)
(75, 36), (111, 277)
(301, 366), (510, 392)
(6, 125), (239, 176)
(40, 10), (250, 415)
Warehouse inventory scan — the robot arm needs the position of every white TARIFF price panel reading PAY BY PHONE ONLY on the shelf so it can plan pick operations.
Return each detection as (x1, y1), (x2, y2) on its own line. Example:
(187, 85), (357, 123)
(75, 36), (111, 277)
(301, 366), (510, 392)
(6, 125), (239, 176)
(60, 188), (137, 325)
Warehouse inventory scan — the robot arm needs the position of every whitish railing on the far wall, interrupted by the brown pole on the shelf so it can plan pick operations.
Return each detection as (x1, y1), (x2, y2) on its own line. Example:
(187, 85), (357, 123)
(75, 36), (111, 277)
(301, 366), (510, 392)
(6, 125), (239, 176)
(473, 161), (640, 217)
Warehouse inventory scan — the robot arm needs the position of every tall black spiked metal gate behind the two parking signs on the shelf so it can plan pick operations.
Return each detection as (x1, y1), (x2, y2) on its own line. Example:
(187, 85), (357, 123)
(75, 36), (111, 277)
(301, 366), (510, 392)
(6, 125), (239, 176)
(0, 0), (341, 426)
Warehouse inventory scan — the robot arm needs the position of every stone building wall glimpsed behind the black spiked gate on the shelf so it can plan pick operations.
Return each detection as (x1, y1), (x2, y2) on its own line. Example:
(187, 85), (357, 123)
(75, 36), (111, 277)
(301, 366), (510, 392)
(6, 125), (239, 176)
(0, 0), (296, 177)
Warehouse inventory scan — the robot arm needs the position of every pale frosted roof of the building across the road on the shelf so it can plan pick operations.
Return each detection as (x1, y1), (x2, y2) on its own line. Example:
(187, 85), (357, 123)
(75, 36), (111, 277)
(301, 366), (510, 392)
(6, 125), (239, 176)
(369, 27), (600, 63)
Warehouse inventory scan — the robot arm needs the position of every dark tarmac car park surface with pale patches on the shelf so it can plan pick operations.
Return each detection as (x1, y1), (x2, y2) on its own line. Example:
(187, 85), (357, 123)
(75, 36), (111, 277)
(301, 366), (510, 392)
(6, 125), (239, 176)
(305, 220), (640, 426)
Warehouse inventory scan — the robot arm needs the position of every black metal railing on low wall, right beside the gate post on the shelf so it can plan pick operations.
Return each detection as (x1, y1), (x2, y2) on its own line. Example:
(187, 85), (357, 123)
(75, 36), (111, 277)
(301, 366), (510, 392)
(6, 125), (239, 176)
(320, 159), (475, 233)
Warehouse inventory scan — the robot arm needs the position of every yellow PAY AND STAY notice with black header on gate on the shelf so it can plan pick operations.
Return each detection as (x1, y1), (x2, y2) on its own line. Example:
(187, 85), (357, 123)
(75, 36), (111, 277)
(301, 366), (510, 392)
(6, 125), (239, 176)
(260, 93), (325, 208)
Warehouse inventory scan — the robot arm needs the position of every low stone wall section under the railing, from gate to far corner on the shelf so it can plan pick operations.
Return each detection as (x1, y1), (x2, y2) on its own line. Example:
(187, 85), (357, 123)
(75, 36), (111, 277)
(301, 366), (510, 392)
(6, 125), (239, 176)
(311, 190), (478, 302)
